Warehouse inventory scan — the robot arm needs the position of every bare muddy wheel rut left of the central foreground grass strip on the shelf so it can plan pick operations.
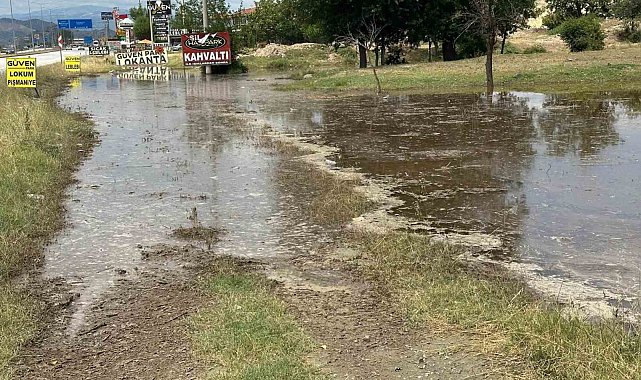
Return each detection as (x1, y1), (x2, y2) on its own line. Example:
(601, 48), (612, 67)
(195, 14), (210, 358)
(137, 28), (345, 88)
(15, 246), (212, 380)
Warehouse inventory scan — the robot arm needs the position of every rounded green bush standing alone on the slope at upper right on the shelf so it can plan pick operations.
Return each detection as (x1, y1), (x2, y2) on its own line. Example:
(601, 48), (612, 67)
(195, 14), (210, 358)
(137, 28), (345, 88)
(558, 16), (605, 51)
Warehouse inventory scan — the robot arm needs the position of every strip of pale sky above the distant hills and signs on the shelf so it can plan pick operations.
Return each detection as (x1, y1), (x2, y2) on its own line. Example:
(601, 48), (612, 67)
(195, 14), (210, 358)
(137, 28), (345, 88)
(0, 0), (245, 18)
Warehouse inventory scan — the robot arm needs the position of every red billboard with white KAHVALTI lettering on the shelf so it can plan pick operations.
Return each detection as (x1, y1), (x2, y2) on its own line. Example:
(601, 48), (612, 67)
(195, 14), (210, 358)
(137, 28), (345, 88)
(182, 32), (231, 66)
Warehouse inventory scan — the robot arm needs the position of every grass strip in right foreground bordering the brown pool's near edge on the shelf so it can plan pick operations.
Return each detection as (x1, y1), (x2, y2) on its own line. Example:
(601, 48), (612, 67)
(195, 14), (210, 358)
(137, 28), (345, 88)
(356, 233), (641, 380)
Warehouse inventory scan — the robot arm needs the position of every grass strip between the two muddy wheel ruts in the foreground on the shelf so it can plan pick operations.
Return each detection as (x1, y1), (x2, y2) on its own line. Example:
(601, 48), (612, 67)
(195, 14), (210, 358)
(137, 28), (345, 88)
(191, 258), (325, 380)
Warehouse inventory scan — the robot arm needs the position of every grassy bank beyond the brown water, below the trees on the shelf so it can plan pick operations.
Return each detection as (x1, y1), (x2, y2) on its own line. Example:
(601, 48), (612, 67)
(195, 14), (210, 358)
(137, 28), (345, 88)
(282, 46), (641, 93)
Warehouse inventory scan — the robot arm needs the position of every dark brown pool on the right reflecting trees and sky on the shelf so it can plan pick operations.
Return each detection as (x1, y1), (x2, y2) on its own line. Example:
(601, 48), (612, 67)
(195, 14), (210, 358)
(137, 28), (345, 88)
(241, 88), (641, 305)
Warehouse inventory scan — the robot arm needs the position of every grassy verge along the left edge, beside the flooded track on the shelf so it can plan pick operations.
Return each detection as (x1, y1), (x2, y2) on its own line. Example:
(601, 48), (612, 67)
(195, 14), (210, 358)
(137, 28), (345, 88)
(0, 65), (94, 379)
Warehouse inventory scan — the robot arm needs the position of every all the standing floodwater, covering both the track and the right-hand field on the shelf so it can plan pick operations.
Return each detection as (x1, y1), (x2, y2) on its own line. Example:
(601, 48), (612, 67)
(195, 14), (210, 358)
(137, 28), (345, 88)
(51, 75), (641, 333)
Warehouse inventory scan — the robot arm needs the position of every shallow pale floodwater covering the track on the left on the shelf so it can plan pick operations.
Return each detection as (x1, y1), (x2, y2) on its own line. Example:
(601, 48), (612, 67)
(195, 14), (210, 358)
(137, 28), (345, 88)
(44, 76), (315, 335)
